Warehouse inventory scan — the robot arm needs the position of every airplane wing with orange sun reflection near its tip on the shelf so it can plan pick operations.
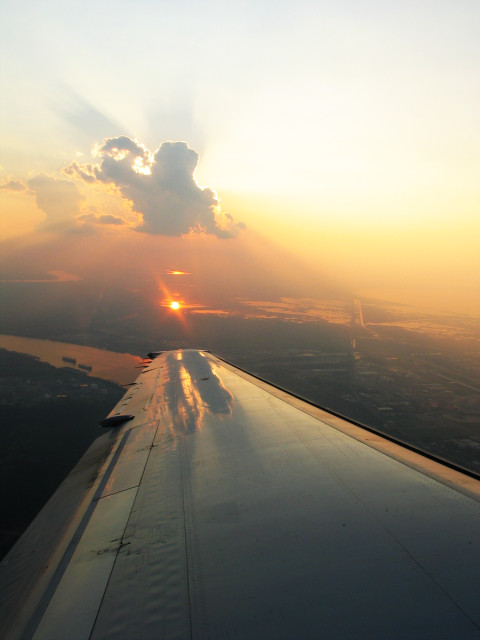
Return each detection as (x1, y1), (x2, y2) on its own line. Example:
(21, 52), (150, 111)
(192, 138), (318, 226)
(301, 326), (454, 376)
(0, 350), (480, 640)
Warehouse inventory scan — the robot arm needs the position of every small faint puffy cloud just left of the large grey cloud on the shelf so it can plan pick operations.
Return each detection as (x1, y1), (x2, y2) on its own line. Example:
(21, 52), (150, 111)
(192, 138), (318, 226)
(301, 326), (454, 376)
(28, 173), (84, 226)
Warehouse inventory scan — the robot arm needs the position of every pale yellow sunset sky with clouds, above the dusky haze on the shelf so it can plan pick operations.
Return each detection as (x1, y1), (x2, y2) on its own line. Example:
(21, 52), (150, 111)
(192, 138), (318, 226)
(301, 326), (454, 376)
(0, 0), (480, 315)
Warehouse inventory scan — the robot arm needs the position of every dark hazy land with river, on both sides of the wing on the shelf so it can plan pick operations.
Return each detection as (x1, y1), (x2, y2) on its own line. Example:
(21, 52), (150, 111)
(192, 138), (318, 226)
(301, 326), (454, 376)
(0, 292), (480, 552)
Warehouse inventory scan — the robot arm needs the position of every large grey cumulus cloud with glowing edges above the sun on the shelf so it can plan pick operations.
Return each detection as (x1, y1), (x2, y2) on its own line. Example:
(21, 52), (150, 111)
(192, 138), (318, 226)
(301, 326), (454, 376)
(64, 136), (244, 238)
